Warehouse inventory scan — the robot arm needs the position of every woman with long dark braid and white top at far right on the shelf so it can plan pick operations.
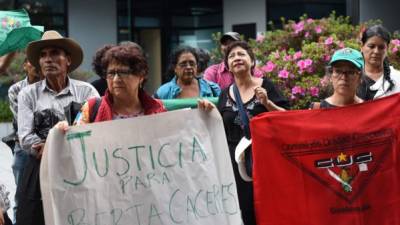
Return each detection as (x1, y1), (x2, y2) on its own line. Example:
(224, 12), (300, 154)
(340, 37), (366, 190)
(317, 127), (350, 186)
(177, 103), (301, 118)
(357, 25), (400, 100)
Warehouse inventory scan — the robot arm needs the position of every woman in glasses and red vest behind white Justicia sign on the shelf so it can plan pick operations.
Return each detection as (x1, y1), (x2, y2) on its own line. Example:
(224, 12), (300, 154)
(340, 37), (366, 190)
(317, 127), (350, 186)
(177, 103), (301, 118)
(69, 45), (166, 124)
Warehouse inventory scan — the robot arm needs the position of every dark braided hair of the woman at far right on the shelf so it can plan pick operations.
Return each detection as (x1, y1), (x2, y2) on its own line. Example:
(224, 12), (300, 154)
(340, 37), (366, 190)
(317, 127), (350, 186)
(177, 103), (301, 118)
(361, 25), (394, 91)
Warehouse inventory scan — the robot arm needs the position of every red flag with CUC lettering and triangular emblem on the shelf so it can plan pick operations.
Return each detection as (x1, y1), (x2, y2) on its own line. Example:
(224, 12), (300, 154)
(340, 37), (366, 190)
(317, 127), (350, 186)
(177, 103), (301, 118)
(251, 95), (400, 225)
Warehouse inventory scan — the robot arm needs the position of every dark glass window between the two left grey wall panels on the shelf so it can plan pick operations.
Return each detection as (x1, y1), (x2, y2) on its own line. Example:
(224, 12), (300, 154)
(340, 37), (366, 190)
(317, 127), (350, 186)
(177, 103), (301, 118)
(117, 0), (223, 79)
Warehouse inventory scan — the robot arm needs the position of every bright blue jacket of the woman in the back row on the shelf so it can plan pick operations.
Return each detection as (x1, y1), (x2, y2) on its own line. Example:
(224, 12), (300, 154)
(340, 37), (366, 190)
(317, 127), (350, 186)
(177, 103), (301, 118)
(154, 76), (221, 99)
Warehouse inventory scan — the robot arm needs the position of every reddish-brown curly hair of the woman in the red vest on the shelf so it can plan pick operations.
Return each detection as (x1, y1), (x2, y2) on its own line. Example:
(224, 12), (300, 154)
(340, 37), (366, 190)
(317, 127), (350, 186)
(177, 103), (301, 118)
(101, 45), (149, 80)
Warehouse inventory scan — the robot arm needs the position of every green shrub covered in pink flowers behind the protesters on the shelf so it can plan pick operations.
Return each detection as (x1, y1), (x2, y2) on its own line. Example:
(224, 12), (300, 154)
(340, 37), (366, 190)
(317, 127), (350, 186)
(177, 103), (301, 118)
(250, 13), (400, 109)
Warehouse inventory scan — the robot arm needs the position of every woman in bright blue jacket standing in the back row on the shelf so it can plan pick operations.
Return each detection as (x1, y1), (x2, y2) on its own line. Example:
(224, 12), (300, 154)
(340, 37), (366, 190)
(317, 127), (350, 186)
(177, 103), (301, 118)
(154, 46), (221, 99)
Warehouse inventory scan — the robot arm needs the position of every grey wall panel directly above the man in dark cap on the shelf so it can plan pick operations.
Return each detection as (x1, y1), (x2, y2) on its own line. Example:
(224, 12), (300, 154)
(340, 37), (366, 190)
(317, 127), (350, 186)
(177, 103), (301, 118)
(223, 0), (267, 33)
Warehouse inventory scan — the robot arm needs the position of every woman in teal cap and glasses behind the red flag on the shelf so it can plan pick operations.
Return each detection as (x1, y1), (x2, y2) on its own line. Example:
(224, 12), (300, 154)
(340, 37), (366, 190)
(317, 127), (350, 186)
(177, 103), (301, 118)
(310, 48), (364, 109)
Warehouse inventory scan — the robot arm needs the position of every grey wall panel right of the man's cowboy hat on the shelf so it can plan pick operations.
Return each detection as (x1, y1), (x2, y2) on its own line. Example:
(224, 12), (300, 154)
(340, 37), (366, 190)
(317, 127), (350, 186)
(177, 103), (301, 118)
(68, 0), (117, 70)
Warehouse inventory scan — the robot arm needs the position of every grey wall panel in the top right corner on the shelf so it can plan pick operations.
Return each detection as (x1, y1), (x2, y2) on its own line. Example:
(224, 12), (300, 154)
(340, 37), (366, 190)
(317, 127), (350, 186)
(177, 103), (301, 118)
(360, 0), (400, 31)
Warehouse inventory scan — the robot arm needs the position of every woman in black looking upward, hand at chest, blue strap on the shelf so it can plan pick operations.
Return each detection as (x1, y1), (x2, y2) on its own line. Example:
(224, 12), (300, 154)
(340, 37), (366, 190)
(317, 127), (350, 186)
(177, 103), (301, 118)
(217, 41), (289, 225)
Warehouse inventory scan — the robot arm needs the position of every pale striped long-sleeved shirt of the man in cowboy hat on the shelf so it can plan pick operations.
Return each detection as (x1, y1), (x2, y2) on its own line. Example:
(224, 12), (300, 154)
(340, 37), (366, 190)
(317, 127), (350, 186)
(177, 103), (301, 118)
(18, 78), (99, 155)
